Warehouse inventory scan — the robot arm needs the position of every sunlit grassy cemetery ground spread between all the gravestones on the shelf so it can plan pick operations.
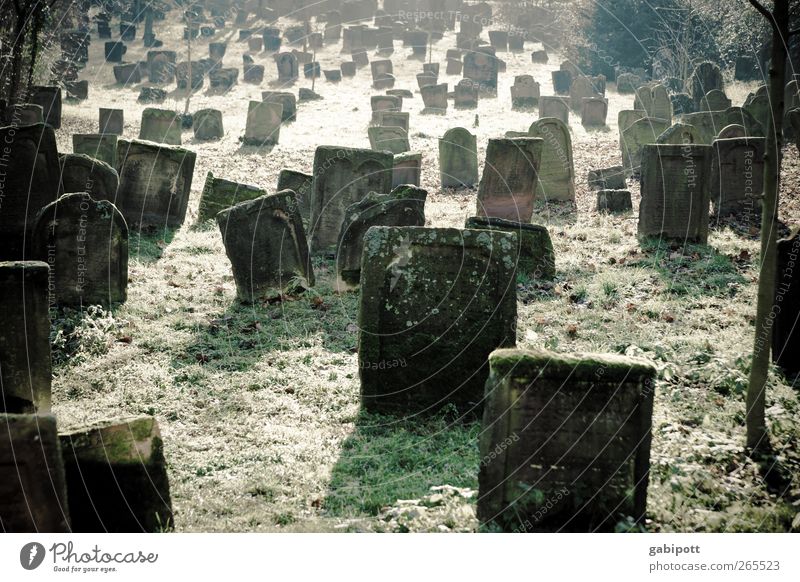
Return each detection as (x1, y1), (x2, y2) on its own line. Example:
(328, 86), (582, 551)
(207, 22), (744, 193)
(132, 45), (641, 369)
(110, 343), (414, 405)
(47, 18), (800, 532)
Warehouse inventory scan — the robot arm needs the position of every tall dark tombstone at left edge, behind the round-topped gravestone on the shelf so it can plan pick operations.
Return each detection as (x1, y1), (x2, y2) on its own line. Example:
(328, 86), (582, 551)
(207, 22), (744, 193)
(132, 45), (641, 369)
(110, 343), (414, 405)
(0, 123), (61, 260)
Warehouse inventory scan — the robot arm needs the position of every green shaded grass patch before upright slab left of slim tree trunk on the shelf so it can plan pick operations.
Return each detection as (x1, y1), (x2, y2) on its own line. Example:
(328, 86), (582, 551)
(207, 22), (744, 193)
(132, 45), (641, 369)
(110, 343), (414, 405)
(626, 239), (747, 297)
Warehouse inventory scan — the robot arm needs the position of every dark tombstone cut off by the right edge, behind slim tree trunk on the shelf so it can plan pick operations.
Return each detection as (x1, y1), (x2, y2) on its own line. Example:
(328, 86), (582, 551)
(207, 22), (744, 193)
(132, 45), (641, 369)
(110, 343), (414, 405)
(772, 229), (800, 376)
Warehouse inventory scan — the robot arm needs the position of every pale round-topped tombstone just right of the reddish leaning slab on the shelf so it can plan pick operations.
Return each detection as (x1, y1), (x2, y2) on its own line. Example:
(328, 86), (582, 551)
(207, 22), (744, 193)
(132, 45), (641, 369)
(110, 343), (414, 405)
(528, 117), (575, 202)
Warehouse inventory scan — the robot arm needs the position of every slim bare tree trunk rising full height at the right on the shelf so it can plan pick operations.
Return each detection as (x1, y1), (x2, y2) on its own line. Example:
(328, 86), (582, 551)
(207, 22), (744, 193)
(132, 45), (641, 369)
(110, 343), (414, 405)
(746, 0), (789, 451)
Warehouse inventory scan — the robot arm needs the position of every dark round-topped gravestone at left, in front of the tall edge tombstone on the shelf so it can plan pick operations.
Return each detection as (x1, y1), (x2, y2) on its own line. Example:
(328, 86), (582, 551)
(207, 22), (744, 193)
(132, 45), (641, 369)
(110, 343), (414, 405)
(33, 192), (128, 309)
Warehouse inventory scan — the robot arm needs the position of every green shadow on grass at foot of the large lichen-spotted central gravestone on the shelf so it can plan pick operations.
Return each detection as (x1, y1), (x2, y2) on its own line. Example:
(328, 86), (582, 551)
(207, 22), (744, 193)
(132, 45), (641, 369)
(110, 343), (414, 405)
(325, 411), (480, 518)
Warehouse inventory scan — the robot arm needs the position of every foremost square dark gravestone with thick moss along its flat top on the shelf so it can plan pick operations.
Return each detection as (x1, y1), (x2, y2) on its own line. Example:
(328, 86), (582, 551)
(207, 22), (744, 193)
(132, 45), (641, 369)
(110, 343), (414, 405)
(478, 350), (656, 532)
